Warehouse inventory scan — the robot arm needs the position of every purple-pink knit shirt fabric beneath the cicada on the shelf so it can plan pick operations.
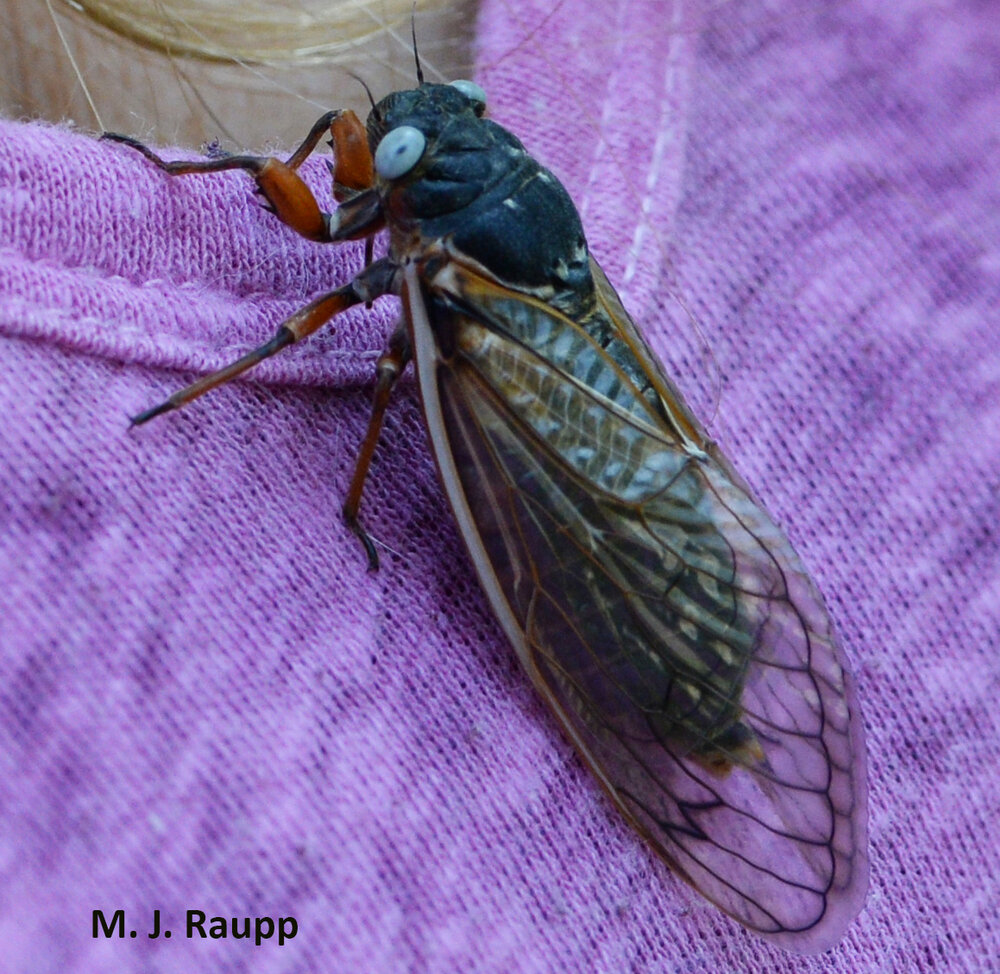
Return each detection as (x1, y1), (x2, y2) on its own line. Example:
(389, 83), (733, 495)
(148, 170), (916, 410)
(0, 0), (1000, 974)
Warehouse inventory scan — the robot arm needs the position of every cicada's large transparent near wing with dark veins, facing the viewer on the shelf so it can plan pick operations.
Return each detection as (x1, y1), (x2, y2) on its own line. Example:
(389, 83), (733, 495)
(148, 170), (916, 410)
(407, 260), (867, 950)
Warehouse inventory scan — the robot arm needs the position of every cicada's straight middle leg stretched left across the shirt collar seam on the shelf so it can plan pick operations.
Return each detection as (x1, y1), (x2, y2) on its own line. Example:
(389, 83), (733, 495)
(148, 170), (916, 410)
(132, 258), (397, 426)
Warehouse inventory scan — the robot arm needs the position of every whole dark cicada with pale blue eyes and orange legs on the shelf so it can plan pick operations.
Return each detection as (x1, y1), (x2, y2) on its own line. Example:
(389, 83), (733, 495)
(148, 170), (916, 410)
(103, 65), (867, 951)
